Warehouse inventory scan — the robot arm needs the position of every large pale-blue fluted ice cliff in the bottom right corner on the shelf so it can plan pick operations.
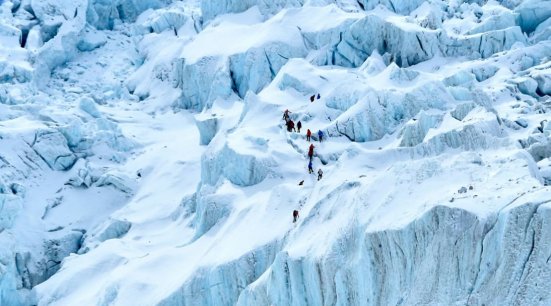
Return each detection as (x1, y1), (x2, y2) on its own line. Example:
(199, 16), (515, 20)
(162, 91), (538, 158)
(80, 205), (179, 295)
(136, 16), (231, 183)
(237, 199), (551, 305)
